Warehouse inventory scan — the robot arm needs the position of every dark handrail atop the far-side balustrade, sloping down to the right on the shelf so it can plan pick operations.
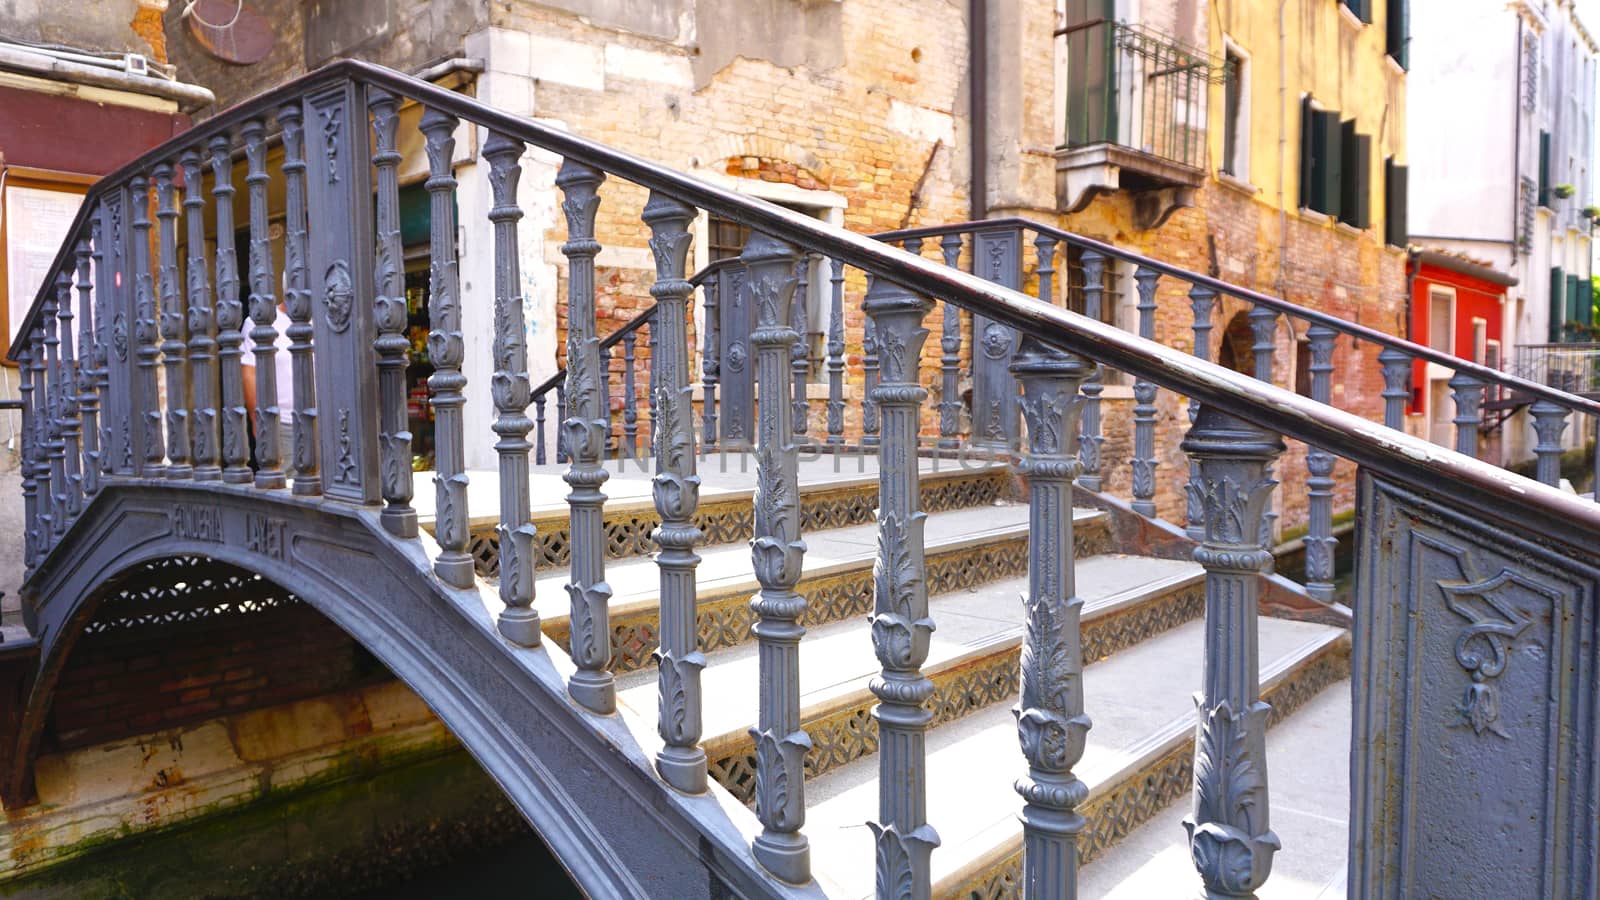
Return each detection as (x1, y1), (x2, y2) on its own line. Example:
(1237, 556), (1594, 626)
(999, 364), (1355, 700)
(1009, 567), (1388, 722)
(872, 216), (1600, 416)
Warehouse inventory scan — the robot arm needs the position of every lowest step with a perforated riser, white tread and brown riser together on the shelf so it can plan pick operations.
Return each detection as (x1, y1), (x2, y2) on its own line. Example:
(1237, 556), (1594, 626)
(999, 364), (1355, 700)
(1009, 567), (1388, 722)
(805, 618), (1349, 897)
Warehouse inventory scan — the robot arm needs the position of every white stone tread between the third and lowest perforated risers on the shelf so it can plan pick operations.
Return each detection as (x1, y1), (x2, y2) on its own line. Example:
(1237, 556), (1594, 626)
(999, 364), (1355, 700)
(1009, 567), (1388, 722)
(805, 618), (1344, 897)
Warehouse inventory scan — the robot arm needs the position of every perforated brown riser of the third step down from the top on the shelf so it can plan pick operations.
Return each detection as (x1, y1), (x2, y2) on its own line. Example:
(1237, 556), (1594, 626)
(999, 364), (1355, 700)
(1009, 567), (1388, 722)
(701, 572), (1205, 802)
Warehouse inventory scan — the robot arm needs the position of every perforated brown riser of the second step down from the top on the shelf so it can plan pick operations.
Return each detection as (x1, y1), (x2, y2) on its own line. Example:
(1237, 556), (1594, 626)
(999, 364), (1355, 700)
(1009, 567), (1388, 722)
(542, 514), (1109, 673)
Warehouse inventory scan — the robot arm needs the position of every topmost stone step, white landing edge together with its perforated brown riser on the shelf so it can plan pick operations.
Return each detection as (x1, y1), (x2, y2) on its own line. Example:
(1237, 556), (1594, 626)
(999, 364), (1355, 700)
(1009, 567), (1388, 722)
(413, 452), (1011, 578)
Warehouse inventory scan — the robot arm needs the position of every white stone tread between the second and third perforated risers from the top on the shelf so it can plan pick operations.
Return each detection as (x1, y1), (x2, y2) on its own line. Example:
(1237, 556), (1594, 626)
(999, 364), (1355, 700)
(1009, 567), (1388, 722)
(618, 550), (1203, 748)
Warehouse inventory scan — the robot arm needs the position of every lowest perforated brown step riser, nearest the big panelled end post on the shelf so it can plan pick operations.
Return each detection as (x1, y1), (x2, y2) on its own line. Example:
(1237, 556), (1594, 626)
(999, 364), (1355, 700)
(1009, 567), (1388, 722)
(933, 631), (1350, 897)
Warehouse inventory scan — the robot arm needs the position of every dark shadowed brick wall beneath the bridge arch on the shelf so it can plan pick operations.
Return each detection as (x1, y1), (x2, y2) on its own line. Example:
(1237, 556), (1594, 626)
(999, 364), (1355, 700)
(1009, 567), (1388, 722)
(45, 604), (392, 751)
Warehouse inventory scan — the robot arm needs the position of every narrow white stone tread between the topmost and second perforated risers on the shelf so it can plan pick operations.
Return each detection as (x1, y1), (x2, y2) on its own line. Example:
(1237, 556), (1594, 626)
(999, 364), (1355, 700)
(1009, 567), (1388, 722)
(534, 504), (1106, 623)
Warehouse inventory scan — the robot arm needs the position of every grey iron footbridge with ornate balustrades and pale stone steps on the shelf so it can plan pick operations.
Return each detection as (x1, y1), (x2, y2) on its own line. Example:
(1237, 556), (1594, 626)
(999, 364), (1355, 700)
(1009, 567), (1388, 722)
(0, 62), (1600, 898)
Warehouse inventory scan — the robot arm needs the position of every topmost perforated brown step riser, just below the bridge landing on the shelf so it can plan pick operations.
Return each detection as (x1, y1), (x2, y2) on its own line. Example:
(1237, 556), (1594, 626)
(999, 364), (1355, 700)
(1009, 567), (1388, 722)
(451, 466), (1013, 578)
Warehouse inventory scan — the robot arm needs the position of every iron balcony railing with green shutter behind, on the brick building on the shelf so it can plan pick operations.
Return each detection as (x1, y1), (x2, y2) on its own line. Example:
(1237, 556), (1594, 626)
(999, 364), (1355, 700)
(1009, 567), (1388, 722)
(1058, 19), (1227, 168)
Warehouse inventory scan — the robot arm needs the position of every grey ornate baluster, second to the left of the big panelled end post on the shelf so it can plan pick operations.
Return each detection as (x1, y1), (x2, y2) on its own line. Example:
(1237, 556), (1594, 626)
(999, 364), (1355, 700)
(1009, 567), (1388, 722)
(1011, 336), (1094, 898)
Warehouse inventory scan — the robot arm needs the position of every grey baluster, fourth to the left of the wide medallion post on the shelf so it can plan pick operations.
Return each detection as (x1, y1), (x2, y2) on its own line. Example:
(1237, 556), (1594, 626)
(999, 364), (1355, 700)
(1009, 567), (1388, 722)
(178, 151), (222, 480)
